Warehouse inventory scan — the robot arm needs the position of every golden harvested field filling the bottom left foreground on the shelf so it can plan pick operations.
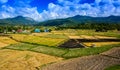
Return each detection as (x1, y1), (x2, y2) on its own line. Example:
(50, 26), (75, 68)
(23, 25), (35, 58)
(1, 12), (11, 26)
(0, 49), (63, 70)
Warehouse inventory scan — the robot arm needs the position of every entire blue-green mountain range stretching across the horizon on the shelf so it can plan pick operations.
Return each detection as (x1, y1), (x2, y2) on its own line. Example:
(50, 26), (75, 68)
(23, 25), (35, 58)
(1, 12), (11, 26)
(0, 15), (120, 26)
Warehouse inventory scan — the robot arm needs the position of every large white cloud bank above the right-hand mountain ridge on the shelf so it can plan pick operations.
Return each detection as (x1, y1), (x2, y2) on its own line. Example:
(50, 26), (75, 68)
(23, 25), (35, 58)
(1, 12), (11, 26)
(38, 0), (120, 20)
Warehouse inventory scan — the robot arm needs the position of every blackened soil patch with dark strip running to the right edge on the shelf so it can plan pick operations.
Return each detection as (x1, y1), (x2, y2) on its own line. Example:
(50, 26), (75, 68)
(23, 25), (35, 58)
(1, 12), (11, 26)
(58, 39), (120, 48)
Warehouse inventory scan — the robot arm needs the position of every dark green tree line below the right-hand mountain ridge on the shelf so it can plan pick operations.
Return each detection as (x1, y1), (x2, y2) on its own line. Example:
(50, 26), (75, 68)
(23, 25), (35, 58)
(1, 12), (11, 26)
(56, 23), (120, 31)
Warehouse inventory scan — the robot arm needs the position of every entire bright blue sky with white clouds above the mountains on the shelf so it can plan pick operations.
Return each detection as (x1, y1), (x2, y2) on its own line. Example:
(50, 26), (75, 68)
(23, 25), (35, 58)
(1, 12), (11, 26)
(0, 0), (120, 21)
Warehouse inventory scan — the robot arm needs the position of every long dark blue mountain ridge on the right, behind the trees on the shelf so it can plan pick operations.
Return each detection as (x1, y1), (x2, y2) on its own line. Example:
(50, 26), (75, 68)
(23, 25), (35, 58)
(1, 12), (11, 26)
(38, 15), (120, 26)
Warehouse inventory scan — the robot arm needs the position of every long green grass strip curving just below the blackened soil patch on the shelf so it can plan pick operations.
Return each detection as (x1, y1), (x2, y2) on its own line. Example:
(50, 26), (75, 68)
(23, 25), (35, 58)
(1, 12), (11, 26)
(3, 43), (120, 59)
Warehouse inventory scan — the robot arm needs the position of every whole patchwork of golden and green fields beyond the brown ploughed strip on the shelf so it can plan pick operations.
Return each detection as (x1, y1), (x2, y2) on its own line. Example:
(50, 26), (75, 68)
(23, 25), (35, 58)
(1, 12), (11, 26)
(0, 29), (120, 70)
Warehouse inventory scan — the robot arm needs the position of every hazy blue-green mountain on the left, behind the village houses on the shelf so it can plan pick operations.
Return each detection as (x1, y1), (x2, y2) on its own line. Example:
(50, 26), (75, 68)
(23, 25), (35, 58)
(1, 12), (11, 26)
(0, 16), (38, 25)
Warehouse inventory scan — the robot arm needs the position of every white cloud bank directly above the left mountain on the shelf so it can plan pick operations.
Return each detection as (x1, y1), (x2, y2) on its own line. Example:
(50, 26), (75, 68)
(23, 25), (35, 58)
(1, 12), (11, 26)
(0, 5), (43, 21)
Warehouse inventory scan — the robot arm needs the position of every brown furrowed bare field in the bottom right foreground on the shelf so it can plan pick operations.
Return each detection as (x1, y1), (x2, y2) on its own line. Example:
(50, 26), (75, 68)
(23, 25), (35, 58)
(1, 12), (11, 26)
(42, 47), (120, 70)
